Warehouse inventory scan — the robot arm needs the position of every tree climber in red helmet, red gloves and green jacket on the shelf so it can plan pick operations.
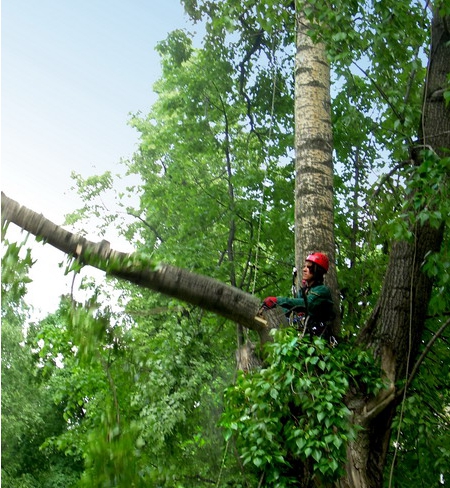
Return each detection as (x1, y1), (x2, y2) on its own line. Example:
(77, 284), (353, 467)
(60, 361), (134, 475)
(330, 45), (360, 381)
(263, 252), (334, 340)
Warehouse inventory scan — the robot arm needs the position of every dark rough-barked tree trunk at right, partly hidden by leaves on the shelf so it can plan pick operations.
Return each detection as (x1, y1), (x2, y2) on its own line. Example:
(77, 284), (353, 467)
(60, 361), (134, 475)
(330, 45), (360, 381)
(341, 7), (450, 488)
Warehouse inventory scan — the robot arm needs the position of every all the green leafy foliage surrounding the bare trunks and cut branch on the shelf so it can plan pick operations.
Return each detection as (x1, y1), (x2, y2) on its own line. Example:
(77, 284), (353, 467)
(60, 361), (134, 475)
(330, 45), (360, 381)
(2, 0), (450, 488)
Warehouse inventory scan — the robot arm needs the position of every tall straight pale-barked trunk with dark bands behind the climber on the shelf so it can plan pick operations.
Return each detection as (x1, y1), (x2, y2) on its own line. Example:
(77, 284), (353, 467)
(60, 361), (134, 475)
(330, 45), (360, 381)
(295, 6), (339, 335)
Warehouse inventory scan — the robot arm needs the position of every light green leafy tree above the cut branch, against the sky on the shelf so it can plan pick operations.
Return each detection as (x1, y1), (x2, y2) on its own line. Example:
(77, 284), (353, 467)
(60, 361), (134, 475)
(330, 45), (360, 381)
(126, 27), (293, 289)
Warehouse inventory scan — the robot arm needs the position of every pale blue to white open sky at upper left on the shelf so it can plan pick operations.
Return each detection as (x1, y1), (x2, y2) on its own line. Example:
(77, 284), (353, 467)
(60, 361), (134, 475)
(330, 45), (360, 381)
(1, 0), (197, 316)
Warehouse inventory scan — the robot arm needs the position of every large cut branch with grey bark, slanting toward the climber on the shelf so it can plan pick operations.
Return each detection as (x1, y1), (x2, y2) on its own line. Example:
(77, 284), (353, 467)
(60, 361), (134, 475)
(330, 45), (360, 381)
(2, 192), (280, 342)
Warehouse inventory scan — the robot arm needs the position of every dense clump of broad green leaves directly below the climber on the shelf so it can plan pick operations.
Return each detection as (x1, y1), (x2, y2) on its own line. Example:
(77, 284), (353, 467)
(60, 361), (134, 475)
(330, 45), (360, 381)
(221, 328), (383, 487)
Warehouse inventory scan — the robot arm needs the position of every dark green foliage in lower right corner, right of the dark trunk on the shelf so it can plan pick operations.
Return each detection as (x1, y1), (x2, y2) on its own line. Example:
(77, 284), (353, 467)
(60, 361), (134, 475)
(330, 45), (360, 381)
(386, 223), (450, 487)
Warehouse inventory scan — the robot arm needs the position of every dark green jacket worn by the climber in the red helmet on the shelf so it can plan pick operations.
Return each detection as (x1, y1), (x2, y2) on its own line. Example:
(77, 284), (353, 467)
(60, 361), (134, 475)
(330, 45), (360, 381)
(277, 284), (334, 322)
